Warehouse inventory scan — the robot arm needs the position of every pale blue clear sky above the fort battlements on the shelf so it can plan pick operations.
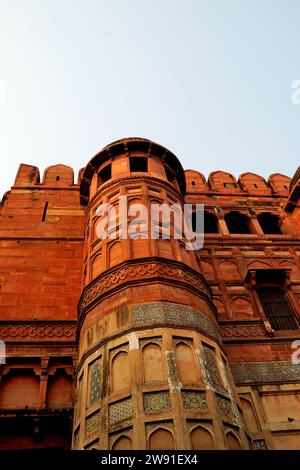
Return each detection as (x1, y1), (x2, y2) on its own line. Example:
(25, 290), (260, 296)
(0, 0), (300, 195)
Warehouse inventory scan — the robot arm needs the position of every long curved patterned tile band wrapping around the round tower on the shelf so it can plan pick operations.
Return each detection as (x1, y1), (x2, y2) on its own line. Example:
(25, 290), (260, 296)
(132, 302), (222, 344)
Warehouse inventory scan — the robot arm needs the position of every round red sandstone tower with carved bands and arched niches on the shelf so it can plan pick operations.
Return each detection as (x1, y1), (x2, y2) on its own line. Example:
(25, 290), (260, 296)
(73, 138), (248, 450)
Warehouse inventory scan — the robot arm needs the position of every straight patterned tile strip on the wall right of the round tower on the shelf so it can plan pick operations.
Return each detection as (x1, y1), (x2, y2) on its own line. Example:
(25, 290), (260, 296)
(230, 362), (300, 384)
